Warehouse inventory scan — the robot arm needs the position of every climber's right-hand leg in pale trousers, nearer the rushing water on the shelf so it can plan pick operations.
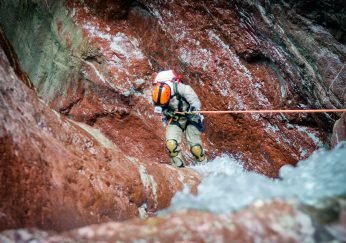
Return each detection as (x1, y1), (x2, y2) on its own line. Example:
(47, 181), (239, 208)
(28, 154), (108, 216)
(186, 124), (208, 164)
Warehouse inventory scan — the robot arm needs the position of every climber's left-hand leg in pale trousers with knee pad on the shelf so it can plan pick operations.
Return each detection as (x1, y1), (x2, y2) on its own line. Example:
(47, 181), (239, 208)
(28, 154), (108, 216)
(166, 124), (184, 167)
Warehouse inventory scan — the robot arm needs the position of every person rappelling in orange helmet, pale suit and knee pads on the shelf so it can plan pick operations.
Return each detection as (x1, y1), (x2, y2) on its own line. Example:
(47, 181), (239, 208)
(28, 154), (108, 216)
(152, 70), (207, 167)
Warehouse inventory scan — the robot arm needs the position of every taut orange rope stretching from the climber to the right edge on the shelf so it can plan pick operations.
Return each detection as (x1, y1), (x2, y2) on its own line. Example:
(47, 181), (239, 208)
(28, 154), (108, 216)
(175, 109), (346, 115)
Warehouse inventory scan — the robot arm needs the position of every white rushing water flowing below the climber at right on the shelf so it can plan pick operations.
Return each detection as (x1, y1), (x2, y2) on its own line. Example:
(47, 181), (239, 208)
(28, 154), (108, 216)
(161, 142), (346, 214)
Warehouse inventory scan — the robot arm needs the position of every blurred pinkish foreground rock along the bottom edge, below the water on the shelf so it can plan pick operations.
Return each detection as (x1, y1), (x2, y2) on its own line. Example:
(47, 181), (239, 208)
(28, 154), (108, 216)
(0, 201), (344, 242)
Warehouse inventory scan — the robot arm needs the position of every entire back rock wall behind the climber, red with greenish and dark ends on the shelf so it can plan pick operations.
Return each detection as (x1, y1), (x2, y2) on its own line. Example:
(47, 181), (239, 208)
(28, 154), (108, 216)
(2, 1), (345, 177)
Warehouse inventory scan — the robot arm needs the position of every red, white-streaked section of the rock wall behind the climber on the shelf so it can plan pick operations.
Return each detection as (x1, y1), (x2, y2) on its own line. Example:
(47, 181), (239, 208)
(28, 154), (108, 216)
(60, 1), (334, 176)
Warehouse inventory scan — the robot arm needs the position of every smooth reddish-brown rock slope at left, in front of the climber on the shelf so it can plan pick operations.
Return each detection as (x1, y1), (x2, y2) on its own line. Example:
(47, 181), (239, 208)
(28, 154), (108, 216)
(0, 42), (199, 230)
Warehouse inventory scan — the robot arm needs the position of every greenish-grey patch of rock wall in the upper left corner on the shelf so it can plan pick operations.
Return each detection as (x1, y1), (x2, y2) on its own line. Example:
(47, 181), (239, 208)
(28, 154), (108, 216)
(0, 0), (88, 102)
